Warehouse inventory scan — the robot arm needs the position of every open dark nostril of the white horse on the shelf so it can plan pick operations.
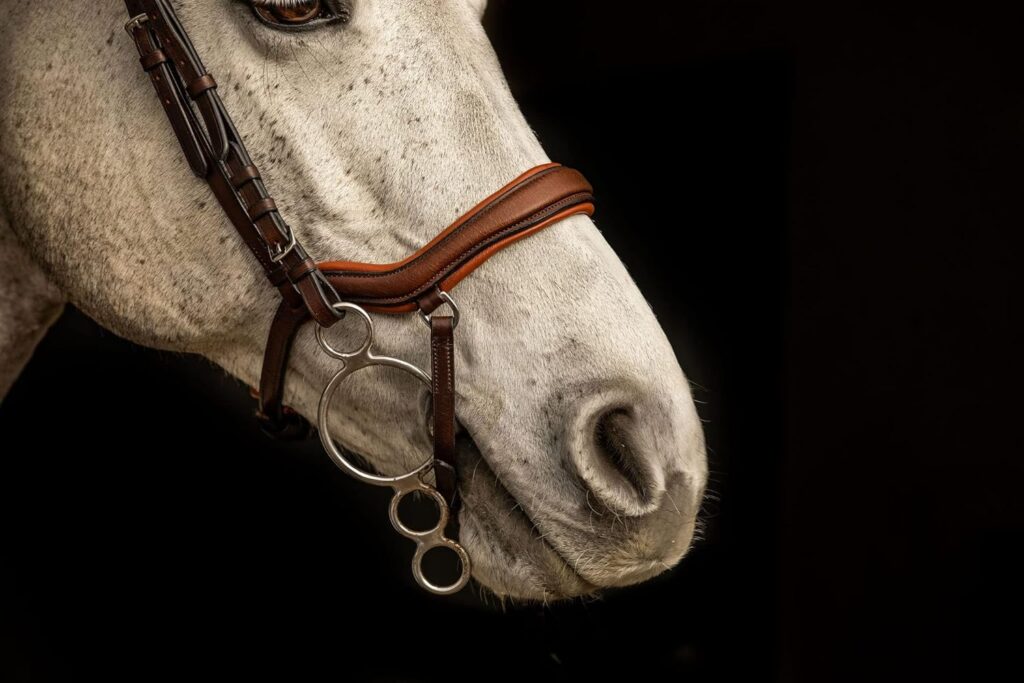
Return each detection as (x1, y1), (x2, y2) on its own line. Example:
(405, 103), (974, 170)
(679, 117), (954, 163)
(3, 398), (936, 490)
(574, 408), (665, 516)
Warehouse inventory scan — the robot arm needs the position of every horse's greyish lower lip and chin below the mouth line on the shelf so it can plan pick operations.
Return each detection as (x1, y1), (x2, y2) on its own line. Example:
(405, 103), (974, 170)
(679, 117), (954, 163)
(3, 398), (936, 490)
(459, 438), (598, 602)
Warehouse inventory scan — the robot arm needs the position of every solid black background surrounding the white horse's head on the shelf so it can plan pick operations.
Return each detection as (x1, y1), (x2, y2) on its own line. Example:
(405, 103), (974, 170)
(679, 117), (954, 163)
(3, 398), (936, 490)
(0, 0), (1024, 682)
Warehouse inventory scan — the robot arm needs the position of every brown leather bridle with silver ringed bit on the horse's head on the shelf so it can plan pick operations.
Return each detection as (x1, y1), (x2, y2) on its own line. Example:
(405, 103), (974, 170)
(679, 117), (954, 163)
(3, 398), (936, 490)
(125, 0), (594, 594)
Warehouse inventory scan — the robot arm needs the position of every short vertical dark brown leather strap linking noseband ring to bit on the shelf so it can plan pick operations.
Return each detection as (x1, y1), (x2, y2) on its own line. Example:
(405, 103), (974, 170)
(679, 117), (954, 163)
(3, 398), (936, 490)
(430, 315), (458, 508)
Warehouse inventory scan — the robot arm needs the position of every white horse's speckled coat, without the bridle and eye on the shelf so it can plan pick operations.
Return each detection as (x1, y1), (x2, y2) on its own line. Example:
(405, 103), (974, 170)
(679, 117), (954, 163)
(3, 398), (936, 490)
(0, 0), (707, 599)
